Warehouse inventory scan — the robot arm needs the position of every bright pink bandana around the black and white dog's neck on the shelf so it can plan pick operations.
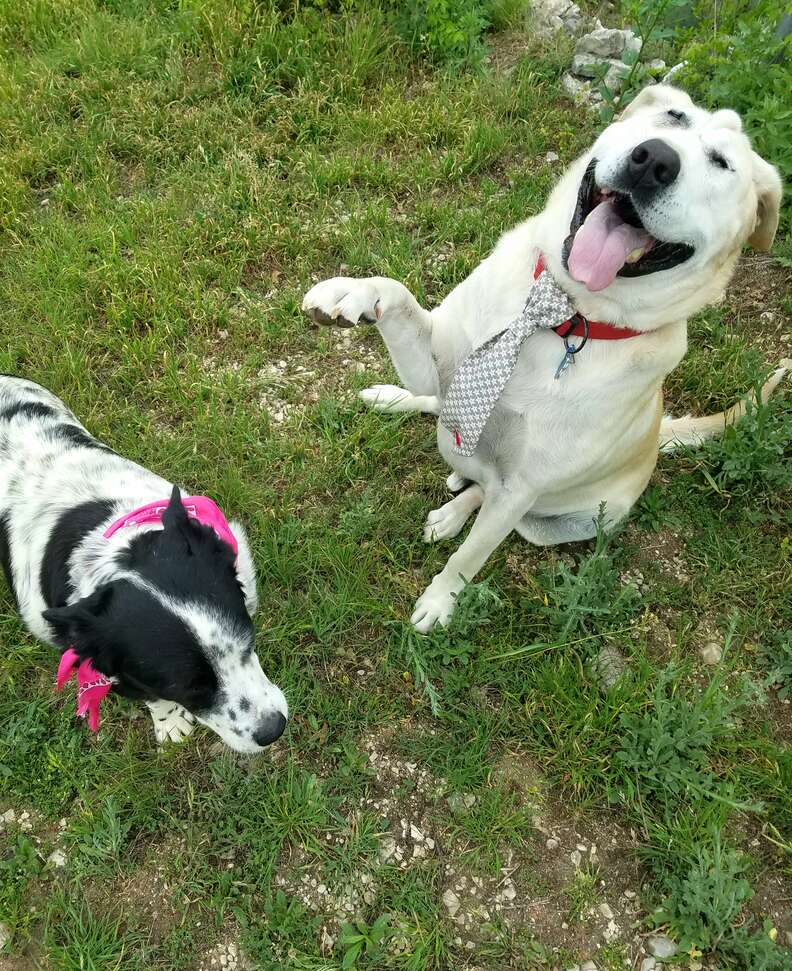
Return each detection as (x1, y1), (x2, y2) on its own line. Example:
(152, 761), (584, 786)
(56, 496), (239, 732)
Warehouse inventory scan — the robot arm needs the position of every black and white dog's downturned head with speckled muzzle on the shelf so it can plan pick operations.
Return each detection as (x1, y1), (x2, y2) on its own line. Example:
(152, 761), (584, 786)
(44, 488), (288, 753)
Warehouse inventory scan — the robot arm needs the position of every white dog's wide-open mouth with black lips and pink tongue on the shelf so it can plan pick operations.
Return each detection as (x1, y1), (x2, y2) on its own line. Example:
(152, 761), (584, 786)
(563, 160), (693, 290)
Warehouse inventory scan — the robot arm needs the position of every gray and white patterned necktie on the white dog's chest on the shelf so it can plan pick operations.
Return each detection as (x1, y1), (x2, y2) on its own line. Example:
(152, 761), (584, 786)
(440, 270), (575, 455)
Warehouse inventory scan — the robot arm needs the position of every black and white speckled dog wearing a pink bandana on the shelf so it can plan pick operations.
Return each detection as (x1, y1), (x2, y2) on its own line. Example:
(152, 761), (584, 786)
(0, 375), (288, 752)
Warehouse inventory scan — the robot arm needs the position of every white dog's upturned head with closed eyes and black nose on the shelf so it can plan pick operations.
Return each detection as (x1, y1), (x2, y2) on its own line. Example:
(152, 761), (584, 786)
(553, 85), (781, 318)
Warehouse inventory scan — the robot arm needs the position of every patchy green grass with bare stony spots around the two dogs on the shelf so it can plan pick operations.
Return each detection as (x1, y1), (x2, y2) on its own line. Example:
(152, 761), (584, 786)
(0, 0), (792, 971)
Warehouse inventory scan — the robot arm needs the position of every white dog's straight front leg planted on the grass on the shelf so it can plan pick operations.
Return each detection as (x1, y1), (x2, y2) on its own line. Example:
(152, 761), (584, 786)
(410, 489), (536, 634)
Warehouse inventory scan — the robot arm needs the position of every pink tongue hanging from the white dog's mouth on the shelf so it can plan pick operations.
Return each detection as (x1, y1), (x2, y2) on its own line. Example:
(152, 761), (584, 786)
(569, 199), (654, 290)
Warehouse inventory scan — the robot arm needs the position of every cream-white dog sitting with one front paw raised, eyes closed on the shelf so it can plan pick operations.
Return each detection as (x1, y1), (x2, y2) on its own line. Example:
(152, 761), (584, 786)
(303, 86), (785, 631)
